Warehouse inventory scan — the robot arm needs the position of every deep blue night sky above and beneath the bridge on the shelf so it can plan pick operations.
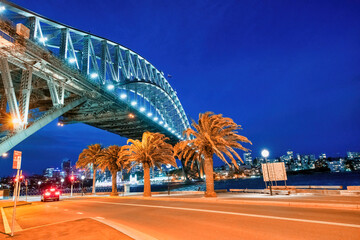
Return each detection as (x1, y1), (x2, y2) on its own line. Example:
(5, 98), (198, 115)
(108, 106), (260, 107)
(0, 0), (360, 175)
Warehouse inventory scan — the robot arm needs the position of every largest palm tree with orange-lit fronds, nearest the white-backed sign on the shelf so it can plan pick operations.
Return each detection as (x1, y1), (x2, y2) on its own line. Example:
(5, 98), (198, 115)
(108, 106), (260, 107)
(175, 112), (252, 197)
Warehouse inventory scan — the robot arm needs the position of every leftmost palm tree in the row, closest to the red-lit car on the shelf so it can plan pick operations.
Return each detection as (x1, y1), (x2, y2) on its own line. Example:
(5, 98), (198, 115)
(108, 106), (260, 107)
(76, 143), (103, 194)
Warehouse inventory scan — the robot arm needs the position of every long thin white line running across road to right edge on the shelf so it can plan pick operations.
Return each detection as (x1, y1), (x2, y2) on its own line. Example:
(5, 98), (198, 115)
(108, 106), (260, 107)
(83, 200), (360, 228)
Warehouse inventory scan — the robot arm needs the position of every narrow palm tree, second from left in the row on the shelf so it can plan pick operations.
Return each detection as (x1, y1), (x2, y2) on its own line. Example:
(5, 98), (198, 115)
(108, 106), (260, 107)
(98, 145), (123, 196)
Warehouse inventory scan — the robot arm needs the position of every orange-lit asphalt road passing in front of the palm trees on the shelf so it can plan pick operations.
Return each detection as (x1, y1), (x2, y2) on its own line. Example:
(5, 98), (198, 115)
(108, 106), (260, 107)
(4, 197), (360, 240)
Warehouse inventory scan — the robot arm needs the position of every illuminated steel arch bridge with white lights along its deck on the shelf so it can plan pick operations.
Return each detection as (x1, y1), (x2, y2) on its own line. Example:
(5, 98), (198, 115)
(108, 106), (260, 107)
(0, 0), (189, 154)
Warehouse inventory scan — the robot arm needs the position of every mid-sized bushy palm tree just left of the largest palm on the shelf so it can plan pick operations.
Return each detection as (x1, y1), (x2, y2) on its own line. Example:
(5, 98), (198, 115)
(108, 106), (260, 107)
(119, 132), (177, 197)
